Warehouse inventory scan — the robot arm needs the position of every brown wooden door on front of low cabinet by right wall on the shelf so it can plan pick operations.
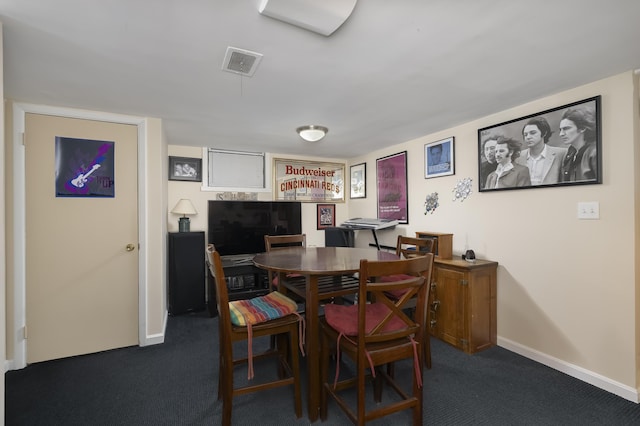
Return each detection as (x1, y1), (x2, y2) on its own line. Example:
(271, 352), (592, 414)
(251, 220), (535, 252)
(431, 266), (465, 348)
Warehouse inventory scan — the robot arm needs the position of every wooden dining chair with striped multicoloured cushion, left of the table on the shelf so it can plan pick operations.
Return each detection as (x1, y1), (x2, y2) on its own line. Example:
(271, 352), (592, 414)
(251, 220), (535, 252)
(206, 244), (302, 426)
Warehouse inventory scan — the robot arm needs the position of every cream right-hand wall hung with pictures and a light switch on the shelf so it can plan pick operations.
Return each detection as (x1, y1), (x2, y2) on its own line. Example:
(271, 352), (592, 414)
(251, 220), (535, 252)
(348, 72), (639, 401)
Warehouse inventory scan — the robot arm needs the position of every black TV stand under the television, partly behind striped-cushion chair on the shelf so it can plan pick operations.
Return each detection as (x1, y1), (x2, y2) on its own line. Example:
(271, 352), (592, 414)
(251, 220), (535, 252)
(207, 254), (269, 317)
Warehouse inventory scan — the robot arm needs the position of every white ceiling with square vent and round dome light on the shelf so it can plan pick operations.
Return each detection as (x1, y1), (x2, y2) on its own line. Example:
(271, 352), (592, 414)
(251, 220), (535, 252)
(0, 0), (640, 158)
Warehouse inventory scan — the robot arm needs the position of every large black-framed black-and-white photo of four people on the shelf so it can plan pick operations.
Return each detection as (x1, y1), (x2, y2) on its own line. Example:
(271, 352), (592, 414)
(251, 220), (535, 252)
(478, 96), (602, 192)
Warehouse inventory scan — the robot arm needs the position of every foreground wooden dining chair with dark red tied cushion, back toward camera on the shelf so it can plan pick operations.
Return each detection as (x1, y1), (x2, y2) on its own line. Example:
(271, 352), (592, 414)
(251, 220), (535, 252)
(320, 253), (433, 426)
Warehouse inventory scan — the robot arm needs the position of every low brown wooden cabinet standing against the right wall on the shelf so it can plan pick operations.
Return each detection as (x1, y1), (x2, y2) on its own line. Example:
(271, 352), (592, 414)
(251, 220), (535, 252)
(429, 258), (498, 353)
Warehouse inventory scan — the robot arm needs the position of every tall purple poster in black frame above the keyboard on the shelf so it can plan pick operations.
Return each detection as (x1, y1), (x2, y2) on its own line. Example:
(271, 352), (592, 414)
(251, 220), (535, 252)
(376, 151), (409, 224)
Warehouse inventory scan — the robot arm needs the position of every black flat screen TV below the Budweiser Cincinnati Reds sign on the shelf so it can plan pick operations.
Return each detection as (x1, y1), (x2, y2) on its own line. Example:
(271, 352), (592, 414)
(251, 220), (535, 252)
(208, 200), (302, 256)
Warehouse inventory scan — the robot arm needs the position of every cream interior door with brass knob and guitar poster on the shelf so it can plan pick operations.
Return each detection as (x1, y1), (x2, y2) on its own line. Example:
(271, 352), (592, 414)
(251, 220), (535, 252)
(25, 113), (138, 363)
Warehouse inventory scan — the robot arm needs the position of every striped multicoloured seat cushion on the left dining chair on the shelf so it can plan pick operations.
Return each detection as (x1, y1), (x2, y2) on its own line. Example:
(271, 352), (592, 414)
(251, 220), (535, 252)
(229, 291), (298, 326)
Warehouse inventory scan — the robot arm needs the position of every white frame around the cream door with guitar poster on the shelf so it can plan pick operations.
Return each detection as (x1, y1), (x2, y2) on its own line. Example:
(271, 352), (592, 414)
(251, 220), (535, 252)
(8, 103), (150, 369)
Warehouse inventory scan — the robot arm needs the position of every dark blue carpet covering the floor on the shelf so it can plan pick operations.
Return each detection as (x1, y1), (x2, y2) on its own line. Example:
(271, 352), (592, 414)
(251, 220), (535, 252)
(5, 312), (640, 426)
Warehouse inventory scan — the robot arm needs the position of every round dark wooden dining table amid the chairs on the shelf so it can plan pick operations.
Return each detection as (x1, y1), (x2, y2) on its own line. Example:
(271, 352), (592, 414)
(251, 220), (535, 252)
(253, 247), (398, 422)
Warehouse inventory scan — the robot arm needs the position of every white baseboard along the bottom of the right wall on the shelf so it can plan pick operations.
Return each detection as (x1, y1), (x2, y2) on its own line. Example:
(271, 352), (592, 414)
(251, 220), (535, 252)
(498, 337), (640, 404)
